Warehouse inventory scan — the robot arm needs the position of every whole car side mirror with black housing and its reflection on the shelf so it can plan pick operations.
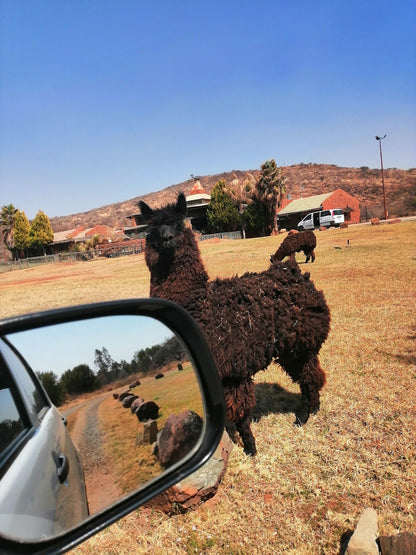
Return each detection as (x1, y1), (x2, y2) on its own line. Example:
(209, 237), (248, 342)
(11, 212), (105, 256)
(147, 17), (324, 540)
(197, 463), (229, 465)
(0, 299), (225, 553)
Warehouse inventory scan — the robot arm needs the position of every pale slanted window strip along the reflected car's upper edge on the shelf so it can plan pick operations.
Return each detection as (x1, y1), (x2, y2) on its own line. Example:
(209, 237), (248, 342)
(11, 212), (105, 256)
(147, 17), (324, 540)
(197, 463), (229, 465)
(1, 342), (50, 419)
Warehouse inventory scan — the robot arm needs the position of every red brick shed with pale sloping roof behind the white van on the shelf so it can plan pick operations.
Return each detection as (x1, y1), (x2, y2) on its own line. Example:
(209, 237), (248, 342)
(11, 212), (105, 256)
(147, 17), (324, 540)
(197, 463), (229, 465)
(277, 189), (360, 229)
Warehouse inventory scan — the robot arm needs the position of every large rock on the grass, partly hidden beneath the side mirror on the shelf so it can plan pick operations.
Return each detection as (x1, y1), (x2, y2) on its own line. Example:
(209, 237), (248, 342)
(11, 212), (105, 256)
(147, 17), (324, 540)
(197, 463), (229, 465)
(147, 431), (233, 515)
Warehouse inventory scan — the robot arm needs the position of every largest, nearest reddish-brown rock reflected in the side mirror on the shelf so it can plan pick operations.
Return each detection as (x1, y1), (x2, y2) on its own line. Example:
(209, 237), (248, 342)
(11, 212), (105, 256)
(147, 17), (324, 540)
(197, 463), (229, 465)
(158, 410), (202, 468)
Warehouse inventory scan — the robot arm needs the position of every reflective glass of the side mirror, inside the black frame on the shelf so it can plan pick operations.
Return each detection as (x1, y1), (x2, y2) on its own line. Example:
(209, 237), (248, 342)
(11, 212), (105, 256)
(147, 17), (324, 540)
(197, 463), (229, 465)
(0, 316), (204, 541)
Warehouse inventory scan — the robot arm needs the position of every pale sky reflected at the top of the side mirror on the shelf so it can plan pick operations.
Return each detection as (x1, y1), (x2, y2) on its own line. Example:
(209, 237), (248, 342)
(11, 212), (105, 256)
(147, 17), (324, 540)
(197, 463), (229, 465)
(7, 316), (174, 377)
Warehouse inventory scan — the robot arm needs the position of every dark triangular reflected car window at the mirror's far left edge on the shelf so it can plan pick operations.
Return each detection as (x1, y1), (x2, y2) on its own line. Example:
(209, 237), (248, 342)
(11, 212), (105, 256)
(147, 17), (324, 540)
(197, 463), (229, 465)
(0, 357), (25, 458)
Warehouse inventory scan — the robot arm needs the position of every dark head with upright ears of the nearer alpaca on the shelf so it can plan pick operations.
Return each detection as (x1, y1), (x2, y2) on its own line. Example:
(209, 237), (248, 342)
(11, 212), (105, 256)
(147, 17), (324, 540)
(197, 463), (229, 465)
(139, 192), (186, 277)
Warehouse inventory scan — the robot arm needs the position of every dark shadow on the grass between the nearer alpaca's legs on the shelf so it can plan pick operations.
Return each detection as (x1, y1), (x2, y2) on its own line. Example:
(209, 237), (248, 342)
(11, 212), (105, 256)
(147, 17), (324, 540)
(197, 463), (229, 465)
(252, 383), (301, 420)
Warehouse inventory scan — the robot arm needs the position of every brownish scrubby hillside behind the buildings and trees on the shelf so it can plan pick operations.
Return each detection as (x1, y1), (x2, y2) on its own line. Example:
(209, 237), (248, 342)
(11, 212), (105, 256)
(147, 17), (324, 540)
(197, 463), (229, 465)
(50, 164), (416, 232)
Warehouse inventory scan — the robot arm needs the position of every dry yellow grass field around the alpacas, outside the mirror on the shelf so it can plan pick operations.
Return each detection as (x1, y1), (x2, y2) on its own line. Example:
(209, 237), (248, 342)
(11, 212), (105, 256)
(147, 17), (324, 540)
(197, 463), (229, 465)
(0, 222), (416, 555)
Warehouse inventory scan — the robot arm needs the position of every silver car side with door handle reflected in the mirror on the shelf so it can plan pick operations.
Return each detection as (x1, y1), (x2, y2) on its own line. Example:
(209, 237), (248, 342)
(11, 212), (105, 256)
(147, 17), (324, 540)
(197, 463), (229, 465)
(0, 339), (88, 540)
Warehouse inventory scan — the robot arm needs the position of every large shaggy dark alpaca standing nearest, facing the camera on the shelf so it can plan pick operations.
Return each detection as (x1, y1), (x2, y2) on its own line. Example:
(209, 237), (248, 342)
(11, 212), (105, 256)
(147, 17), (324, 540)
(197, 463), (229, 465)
(139, 193), (330, 455)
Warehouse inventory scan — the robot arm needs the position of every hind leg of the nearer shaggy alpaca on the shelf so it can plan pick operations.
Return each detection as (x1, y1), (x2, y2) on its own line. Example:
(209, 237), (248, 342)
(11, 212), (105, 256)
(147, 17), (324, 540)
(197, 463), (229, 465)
(296, 356), (325, 426)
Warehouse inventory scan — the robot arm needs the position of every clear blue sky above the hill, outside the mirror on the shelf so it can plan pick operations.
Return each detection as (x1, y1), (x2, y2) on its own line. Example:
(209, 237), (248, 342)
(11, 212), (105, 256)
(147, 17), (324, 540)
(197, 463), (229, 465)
(0, 0), (416, 219)
